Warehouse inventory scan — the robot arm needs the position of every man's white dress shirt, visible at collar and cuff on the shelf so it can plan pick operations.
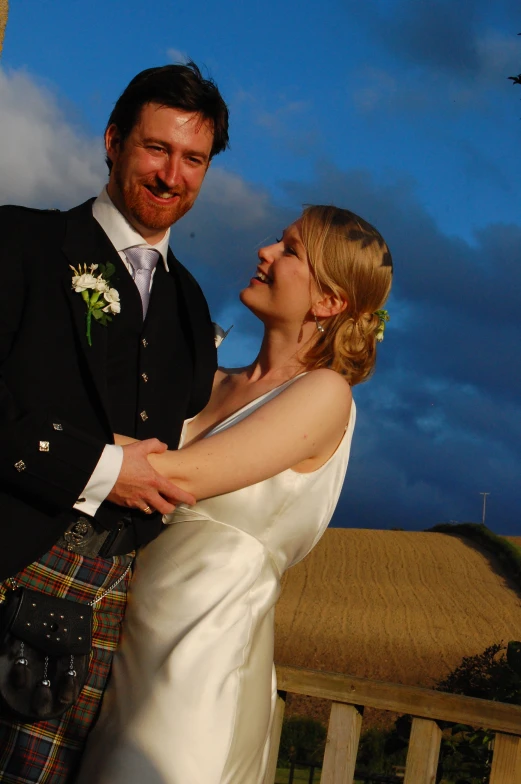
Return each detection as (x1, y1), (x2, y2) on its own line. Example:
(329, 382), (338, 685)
(74, 188), (170, 516)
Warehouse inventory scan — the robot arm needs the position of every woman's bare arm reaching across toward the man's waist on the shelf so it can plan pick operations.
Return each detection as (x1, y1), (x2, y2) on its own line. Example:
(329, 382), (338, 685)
(149, 369), (351, 499)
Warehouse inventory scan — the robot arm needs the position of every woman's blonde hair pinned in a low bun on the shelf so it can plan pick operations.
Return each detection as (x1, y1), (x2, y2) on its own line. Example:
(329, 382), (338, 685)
(300, 205), (393, 386)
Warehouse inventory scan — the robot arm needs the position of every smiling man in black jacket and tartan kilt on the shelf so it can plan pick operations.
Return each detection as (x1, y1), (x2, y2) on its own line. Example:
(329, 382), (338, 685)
(0, 63), (228, 784)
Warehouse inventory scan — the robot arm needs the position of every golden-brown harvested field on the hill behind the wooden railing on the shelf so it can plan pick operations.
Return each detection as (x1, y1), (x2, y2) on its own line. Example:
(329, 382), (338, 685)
(275, 528), (521, 724)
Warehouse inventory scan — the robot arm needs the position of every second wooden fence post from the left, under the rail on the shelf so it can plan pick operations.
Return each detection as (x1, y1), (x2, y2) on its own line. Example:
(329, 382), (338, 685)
(320, 702), (362, 784)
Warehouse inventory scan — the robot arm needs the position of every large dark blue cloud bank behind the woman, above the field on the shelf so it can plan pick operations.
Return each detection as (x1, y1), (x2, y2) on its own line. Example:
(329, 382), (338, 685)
(192, 163), (521, 533)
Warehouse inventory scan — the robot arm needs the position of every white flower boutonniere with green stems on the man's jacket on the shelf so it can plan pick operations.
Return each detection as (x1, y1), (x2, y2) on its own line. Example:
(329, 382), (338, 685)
(71, 262), (121, 346)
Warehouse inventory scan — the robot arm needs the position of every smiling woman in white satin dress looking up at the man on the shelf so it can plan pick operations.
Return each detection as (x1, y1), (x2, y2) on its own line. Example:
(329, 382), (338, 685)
(79, 206), (392, 784)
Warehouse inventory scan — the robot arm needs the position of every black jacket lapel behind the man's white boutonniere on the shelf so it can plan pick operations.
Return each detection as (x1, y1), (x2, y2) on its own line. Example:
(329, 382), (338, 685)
(62, 199), (122, 429)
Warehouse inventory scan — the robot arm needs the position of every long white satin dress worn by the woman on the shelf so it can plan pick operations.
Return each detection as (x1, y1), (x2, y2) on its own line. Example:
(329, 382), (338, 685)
(77, 382), (356, 784)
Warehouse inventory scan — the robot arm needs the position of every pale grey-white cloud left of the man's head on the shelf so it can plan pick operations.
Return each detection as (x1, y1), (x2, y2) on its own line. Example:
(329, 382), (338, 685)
(0, 69), (106, 207)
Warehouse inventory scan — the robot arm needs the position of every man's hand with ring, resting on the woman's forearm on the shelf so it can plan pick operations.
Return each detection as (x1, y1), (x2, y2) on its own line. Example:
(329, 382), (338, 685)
(107, 438), (195, 514)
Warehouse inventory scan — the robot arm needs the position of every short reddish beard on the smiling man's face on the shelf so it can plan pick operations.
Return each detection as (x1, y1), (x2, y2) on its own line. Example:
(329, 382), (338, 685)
(114, 171), (193, 231)
